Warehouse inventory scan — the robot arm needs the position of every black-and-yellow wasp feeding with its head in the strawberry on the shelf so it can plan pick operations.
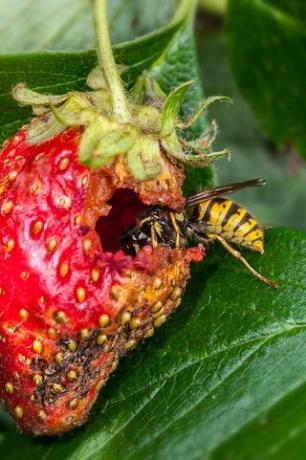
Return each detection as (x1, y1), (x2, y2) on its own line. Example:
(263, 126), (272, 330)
(121, 178), (278, 287)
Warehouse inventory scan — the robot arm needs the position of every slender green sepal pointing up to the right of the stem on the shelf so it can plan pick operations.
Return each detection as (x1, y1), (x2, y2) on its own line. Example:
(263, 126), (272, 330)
(160, 81), (193, 138)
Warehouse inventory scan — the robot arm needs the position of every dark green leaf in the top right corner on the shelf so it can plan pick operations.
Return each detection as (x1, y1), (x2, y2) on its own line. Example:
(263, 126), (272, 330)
(227, 0), (306, 155)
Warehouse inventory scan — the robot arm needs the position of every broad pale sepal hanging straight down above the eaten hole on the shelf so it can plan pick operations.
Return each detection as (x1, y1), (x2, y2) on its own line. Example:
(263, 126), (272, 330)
(127, 136), (162, 181)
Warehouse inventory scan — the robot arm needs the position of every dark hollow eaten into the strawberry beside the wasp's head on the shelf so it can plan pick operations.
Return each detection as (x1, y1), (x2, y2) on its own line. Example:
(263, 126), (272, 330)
(96, 189), (146, 253)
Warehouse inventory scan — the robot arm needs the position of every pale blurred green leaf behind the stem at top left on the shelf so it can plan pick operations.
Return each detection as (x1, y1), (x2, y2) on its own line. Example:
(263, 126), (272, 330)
(0, 0), (177, 53)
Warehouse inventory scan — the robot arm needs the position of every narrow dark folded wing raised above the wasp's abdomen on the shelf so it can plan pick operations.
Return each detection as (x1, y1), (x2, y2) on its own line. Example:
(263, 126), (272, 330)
(186, 178), (266, 207)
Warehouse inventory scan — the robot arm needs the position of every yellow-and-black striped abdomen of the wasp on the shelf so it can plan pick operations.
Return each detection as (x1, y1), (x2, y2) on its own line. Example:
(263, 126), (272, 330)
(196, 197), (264, 254)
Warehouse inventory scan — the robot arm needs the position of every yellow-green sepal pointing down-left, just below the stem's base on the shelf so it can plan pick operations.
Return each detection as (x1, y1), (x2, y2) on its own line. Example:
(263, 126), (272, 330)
(86, 129), (137, 168)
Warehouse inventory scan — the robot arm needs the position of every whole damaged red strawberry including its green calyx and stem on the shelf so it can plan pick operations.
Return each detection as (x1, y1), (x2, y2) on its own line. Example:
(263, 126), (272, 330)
(0, 0), (224, 435)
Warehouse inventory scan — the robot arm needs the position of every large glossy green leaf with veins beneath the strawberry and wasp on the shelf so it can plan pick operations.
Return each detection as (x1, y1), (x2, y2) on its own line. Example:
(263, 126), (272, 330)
(0, 230), (306, 460)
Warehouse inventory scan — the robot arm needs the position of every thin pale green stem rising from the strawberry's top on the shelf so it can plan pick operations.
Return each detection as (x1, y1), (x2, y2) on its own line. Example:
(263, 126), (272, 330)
(94, 0), (131, 123)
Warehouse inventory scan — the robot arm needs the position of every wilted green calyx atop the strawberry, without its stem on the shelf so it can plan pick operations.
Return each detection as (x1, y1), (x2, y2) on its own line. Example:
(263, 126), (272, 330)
(13, 74), (229, 181)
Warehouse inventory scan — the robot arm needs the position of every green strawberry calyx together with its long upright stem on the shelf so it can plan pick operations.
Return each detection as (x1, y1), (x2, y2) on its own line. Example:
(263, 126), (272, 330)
(13, 0), (229, 181)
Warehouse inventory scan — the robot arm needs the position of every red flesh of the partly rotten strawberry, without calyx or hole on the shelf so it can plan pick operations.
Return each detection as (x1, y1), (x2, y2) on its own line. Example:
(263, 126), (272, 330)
(0, 129), (206, 435)
